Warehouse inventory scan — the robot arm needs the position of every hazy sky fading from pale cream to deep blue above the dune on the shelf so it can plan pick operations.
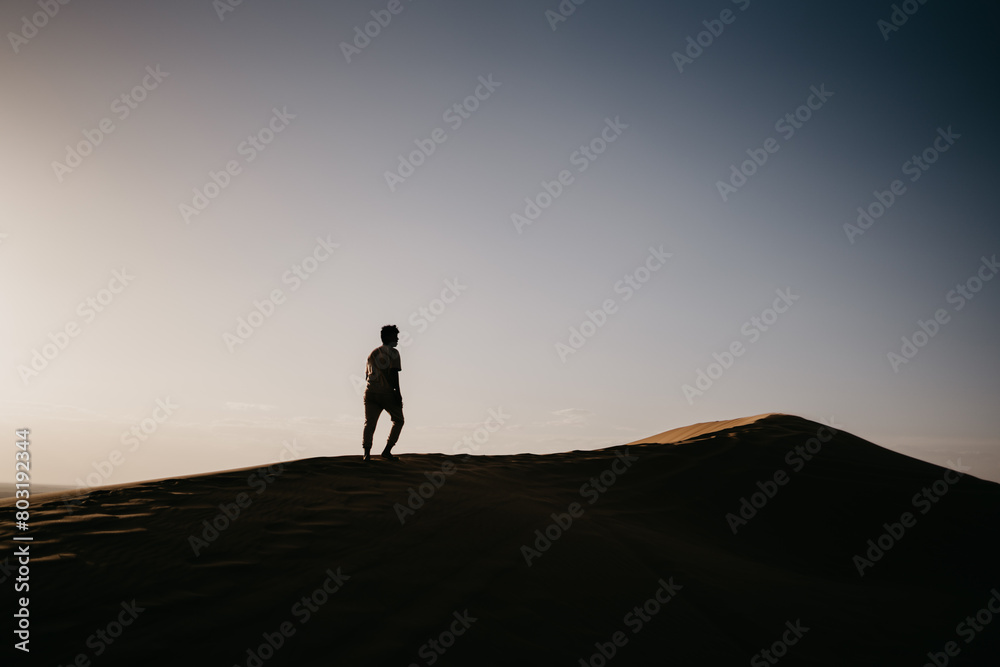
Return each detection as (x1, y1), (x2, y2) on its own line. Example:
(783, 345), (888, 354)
(0, 0), (1000, 484)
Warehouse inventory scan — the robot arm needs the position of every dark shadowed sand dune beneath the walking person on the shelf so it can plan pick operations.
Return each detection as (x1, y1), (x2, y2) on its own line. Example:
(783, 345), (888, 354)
(0, 415), (1000, 667)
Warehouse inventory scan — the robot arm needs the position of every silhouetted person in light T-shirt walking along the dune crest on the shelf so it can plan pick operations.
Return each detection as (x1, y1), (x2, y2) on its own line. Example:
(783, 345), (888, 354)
(362, 324), (403, 461)
